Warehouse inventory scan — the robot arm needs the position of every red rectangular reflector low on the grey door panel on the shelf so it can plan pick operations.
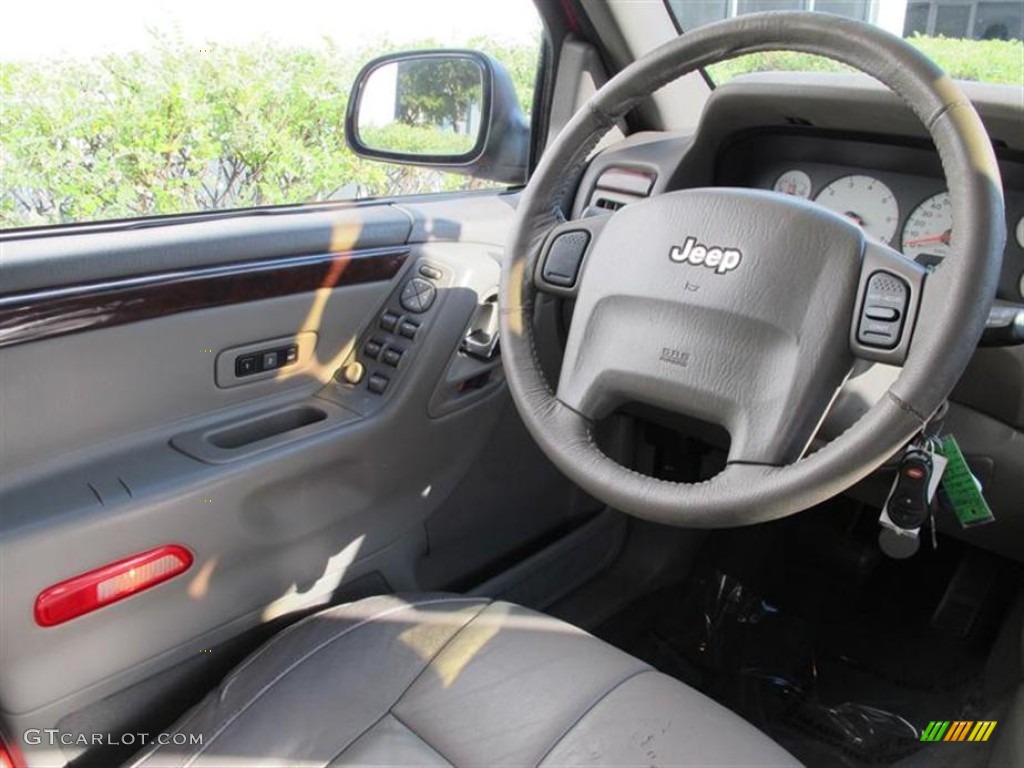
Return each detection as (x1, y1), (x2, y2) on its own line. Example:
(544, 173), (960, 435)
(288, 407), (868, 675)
(36, 544), (193, 627)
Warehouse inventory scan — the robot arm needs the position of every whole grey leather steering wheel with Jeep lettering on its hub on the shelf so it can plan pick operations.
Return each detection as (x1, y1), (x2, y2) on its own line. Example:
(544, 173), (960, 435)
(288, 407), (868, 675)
(500, 12), (1006, 527)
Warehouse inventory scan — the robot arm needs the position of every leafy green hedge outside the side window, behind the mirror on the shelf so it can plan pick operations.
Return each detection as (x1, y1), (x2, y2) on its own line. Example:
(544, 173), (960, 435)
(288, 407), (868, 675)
(0, 37), (538, 228)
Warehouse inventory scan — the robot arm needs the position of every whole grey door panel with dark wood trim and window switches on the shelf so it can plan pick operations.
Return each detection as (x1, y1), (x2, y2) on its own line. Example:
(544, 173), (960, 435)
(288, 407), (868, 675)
(0, 195), (593, 764)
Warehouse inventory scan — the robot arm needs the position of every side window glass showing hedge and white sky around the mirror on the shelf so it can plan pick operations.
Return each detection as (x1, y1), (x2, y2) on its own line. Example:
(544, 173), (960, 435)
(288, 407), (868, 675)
(0, 0), (541, 229)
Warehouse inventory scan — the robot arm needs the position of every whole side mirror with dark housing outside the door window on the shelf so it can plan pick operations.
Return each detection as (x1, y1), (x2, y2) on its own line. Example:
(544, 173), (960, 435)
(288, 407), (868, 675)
(345, 50), (529, 184)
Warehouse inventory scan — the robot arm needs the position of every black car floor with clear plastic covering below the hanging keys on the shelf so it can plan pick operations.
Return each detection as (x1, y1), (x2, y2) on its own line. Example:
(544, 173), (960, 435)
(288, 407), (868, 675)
(595, 501), (1021, 768)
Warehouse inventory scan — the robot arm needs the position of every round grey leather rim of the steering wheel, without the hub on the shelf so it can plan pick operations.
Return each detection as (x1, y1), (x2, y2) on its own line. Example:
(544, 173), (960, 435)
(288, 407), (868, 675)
(500, 12), (1006, 527)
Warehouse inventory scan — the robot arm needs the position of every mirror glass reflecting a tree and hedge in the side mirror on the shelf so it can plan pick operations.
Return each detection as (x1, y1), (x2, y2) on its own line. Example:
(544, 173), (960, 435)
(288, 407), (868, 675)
(356, 56), (484, 157)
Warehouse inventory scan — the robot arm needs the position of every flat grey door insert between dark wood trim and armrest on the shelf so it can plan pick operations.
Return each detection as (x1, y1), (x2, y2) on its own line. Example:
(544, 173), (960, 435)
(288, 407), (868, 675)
(0, 283), (387, 480)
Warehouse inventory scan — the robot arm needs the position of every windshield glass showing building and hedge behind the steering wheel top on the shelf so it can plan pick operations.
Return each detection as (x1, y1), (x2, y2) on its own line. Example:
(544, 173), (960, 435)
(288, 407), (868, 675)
(667, 0), (1024, 86)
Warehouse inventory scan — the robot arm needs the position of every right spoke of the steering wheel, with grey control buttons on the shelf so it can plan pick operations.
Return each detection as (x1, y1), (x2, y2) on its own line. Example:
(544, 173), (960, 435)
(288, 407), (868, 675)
(850, 239), (928, 366)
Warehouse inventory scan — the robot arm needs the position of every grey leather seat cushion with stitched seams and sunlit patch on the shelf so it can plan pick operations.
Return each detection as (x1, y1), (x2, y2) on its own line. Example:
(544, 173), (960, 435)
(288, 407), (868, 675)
(136, 595), (799, 766)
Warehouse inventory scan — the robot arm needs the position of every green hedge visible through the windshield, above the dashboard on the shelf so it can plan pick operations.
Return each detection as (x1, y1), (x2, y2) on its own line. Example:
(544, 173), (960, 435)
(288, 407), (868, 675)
(708, 36), (1024, 87)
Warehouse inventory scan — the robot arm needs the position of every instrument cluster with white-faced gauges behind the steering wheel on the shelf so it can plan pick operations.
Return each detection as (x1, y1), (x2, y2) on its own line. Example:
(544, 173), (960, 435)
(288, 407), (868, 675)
(716, 129), (1024, 301)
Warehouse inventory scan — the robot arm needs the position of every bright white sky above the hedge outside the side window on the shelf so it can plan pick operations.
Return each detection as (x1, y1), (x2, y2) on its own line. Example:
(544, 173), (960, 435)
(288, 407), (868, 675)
(0, 0), (540, 61)
